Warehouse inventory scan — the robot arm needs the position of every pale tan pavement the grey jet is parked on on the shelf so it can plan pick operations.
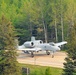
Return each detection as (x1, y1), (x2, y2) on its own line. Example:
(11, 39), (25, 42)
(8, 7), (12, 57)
(17, 51), (67, 68)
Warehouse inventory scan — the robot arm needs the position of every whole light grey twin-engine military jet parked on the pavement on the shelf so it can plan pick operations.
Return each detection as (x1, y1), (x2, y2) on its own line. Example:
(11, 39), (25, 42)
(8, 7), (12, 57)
(18, 37), (67, 57)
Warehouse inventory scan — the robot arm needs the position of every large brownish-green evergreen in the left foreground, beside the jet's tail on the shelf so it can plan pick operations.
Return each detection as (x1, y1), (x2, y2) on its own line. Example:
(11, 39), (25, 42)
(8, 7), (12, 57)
(0, 16), (21, 75)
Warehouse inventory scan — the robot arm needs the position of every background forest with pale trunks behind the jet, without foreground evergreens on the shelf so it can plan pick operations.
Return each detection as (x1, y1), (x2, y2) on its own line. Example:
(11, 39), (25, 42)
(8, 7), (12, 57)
(0, 0), (76, 44)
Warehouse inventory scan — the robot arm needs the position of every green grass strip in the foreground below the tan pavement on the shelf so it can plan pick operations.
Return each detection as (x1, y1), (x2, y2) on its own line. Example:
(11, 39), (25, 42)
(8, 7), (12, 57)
(20, 64), (63, 75)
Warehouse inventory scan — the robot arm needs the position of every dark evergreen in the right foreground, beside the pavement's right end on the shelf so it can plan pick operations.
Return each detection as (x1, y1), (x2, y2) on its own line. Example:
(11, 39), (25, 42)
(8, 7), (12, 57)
(63, 20), (76, 75)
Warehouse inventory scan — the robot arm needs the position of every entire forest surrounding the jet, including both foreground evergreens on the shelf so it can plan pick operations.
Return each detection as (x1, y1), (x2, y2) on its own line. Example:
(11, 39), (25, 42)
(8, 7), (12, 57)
(0, 0), (76, 75)
